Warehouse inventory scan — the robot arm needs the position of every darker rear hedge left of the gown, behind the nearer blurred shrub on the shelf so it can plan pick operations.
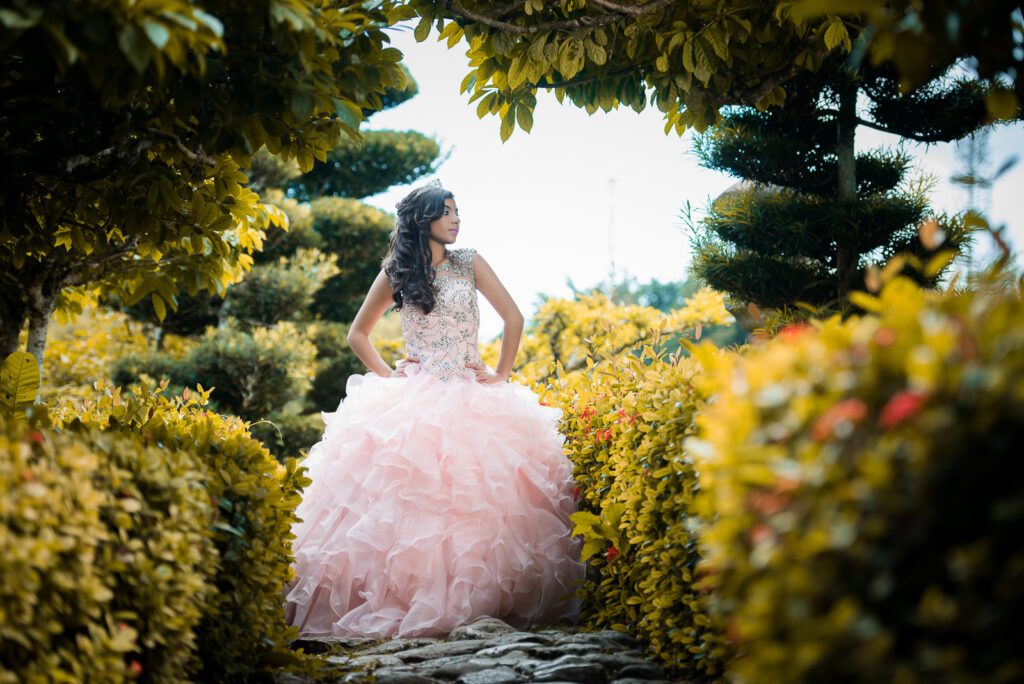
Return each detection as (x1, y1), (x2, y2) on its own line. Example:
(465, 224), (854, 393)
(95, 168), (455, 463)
(53, 382), (313, 682)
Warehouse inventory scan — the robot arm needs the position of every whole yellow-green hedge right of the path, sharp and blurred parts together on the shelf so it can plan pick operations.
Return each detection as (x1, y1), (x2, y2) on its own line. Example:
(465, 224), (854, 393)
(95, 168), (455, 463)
(561, 263), (1024, 682)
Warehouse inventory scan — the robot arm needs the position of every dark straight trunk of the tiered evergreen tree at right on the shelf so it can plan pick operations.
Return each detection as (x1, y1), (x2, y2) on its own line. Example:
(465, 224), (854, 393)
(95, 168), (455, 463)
(836, 71), (859, 306)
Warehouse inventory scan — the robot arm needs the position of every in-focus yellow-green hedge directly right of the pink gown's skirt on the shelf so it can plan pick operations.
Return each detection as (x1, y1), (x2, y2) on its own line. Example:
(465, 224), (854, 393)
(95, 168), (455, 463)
(548, 342), (722, 676)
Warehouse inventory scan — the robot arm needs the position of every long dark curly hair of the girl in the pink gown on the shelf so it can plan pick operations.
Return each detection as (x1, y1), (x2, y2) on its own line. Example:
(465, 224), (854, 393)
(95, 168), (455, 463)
(382, 181), (455, 313)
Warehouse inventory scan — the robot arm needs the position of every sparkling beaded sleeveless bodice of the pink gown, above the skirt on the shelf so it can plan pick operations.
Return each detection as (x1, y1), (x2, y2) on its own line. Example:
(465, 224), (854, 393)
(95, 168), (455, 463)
(400, 249), (482, 380)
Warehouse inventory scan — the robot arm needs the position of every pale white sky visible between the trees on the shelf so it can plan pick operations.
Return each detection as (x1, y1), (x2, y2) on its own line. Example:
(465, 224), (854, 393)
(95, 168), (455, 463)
(365, 28), (1024, 340)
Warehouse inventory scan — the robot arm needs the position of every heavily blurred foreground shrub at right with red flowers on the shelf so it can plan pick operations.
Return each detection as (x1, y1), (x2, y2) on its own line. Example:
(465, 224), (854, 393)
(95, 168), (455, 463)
(685, 277), (1024, 682)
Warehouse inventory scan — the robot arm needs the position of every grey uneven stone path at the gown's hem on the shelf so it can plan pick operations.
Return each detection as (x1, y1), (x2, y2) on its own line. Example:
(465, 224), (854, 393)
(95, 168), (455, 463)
(276, 617), (696, 684)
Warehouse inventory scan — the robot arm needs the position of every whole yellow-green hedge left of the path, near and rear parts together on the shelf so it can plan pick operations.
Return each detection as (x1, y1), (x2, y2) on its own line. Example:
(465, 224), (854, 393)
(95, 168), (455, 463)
(0, 381), (314, 681)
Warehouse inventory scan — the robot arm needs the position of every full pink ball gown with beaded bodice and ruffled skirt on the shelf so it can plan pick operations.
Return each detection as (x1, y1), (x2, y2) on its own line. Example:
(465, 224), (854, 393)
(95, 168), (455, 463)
(285, 249), (584, 637)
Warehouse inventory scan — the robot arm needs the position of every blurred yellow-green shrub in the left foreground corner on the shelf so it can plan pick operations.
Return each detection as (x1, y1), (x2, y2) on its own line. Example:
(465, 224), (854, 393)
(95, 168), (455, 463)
(0, 417), (216, 682)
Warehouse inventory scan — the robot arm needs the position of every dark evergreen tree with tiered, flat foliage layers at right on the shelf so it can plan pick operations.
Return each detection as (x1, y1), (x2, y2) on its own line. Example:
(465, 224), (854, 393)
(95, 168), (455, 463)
(693, 58), (988, 308)
